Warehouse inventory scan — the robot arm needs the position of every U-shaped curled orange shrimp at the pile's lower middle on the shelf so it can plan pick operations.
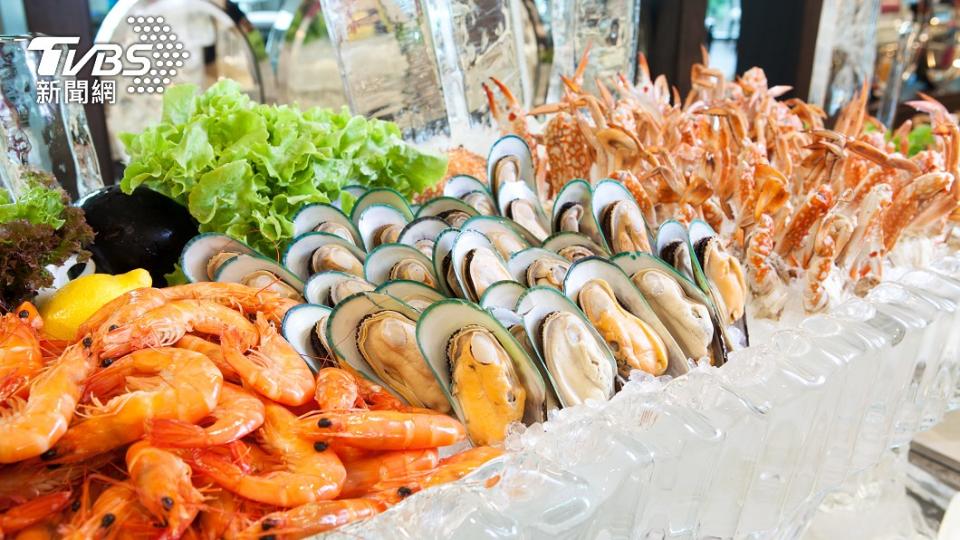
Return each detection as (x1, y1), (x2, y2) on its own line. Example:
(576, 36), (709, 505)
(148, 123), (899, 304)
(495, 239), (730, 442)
(192, 403), (346, 508)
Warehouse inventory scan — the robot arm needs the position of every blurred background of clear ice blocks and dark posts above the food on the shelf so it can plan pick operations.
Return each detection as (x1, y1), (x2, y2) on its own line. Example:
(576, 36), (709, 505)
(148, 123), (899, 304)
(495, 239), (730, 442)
(0, 0), (960, 189)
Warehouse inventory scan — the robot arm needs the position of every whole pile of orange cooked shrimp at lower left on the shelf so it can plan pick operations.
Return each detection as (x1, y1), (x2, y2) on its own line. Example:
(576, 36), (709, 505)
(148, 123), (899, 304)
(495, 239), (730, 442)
(0, 283), (500, 539)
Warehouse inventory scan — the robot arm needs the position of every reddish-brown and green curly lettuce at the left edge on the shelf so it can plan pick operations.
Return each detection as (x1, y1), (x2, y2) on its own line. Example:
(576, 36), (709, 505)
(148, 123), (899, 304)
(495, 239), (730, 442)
(0, 172), (93, 310)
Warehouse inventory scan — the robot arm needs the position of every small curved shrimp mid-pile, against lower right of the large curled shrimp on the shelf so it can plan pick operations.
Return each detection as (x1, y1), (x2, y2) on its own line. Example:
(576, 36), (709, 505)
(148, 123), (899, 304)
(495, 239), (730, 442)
(147, 383), (264, 448)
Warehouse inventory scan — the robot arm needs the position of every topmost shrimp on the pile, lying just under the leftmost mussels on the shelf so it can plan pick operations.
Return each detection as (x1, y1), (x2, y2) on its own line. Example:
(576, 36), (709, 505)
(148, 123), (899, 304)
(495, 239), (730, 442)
(163, 282), (298, 325)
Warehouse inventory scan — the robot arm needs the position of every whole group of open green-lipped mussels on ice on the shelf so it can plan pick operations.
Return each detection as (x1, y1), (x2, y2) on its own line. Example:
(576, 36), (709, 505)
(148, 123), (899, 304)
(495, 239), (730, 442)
(181, 136), (748, 444)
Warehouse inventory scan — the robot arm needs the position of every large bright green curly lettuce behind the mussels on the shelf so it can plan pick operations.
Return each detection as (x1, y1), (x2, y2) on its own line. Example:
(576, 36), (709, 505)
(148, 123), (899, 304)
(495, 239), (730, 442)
(120, 80), (447, 253)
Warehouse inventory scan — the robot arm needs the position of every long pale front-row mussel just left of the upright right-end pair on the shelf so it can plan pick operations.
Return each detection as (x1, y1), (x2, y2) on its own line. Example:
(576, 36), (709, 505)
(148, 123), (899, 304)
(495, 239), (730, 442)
(613, 253), (727, 366)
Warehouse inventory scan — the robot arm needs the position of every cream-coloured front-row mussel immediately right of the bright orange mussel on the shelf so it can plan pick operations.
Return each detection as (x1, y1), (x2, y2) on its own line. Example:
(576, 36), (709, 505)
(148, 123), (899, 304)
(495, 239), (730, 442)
(517, 287), (617, 407)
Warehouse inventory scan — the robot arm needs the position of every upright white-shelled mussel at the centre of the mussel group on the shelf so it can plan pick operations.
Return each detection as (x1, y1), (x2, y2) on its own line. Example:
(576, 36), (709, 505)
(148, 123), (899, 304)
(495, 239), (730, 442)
(451, 231), (513, 302)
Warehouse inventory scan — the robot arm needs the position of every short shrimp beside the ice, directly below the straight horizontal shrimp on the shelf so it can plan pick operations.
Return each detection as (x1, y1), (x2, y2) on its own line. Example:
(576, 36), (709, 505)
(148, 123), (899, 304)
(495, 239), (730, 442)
(340, 449), (440, 498)
